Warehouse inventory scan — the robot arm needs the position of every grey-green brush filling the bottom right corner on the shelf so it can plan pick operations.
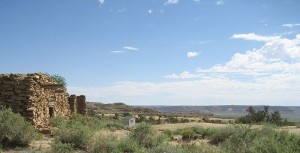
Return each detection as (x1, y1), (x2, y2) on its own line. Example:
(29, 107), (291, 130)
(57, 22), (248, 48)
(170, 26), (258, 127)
(211, 126), (300, 153)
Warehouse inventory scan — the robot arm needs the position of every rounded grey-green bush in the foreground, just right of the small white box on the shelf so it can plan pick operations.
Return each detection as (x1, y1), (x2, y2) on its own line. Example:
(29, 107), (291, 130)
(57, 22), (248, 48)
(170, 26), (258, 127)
(130, 123), (165, 148)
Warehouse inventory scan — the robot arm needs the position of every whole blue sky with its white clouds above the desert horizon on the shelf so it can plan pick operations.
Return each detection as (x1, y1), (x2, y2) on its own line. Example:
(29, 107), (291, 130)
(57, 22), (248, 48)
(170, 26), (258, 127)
(0, 0), (300, 105)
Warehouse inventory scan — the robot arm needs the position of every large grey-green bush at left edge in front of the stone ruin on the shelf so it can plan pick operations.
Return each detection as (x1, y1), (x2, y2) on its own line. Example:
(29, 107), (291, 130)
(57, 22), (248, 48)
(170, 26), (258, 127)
(0, 109), (37, 149)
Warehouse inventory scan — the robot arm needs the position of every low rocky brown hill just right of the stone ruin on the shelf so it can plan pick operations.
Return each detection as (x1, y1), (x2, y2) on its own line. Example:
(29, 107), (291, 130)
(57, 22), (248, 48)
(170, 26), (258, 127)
(87, 102), (160, 114)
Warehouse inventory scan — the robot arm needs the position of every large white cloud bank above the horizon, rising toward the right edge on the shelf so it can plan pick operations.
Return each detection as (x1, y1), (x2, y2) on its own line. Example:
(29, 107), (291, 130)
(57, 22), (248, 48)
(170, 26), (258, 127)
(74, 34), (300, 105)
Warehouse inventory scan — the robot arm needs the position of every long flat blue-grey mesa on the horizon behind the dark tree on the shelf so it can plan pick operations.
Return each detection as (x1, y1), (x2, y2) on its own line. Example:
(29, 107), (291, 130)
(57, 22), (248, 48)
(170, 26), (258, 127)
(141, 105), (300, 122)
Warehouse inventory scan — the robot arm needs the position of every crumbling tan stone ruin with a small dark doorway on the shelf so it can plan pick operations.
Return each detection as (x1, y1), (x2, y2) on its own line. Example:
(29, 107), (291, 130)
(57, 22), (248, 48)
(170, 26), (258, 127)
(0, 73), (87, 131)
